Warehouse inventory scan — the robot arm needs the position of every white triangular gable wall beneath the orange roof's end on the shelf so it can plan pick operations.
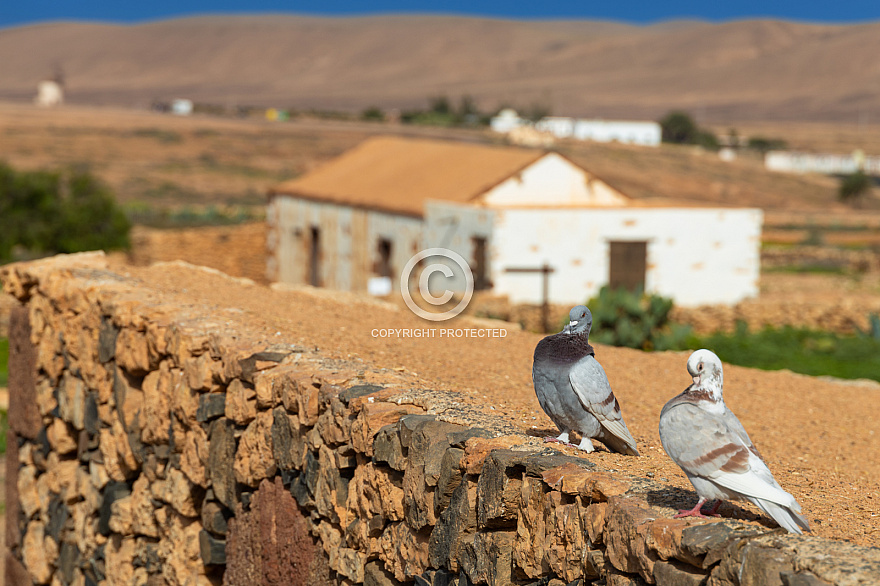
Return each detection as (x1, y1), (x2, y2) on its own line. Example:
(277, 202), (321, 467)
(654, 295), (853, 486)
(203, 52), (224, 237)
(480, 153), (629, 207)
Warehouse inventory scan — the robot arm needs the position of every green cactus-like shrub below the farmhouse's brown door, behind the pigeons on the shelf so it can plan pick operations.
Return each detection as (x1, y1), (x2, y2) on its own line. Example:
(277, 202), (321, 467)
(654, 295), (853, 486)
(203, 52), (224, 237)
(587, 286), (691, 350)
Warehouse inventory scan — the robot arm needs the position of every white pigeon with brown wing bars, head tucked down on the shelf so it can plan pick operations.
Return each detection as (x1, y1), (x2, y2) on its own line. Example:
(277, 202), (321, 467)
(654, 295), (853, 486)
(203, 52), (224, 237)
(660, 350), (810, 533)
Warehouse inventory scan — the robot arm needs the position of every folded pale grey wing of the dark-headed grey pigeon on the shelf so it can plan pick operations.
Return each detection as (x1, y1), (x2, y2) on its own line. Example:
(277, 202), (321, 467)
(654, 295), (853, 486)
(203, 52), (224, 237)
(568, 356), (639, 455)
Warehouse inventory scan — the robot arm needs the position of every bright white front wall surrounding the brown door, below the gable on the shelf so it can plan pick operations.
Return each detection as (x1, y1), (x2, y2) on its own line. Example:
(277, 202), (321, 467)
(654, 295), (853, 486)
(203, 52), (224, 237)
(491, 208), (763, 306)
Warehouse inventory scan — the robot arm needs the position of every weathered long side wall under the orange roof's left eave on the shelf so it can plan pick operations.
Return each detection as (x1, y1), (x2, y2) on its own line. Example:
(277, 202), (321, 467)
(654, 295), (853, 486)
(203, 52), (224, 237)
(268, 196), (422, 291)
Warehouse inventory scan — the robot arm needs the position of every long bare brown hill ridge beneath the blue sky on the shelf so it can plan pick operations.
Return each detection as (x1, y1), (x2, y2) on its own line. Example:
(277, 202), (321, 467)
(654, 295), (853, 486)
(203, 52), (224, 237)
(0, 15), (880, 122)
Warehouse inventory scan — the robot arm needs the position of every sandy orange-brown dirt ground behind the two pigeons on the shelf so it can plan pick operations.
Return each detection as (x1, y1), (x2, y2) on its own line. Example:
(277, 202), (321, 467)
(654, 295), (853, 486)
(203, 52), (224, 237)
(108, 258), (880, 546)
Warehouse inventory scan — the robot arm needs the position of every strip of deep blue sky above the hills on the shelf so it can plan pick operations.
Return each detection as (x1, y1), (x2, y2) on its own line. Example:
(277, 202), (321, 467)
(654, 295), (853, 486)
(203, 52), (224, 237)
(0, 0), (880, 27)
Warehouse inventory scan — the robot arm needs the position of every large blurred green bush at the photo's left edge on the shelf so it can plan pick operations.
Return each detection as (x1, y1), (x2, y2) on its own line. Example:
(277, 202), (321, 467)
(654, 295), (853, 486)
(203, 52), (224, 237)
(0, 163), (130, 263)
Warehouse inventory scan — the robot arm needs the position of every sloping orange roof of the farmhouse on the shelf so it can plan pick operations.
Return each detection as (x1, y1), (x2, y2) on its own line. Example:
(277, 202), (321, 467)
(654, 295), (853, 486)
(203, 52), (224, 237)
(270, 136), (546, 216)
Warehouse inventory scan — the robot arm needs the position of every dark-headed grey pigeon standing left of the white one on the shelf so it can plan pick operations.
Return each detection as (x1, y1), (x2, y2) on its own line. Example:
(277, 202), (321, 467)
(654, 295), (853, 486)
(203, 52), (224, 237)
(532, 305), (639, 456)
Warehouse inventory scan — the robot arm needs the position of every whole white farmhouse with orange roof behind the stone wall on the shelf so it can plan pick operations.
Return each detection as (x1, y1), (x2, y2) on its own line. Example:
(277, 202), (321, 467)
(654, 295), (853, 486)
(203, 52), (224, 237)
(268, 137), (762, 306)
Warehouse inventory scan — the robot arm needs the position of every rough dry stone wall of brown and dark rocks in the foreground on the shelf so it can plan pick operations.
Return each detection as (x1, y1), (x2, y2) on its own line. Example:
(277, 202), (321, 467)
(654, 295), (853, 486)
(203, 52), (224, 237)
(0, 254), (880, 586)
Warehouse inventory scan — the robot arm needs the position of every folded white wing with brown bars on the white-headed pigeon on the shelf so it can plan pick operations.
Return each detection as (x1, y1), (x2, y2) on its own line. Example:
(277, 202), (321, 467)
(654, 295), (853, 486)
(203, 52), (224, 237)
(660, 403), (797, 506)
